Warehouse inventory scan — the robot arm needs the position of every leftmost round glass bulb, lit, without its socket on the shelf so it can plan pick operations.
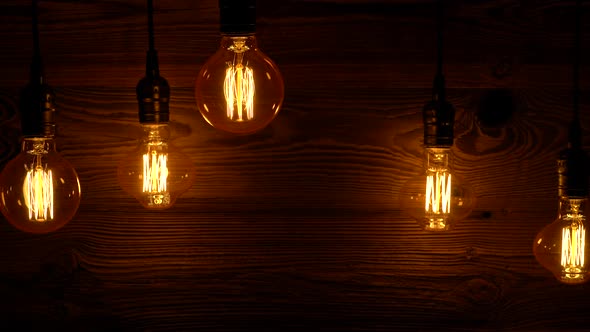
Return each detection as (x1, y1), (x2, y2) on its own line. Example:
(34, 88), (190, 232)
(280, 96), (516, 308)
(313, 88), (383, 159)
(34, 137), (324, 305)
(0, 137), (80, 233)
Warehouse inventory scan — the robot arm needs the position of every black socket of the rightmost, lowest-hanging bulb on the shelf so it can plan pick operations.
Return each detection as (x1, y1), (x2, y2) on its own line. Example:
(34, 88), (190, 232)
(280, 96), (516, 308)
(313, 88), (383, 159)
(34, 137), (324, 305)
(557, 147), (590, 198)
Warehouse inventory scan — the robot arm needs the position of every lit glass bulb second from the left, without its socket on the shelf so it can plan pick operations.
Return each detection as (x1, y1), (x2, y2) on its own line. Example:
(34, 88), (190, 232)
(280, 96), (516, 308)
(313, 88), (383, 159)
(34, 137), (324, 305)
(117, 124), (194, 210)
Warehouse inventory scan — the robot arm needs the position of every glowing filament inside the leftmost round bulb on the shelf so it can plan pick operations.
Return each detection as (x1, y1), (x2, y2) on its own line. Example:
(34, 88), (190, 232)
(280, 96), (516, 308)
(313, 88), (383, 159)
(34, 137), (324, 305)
(23, 165), (53, 221)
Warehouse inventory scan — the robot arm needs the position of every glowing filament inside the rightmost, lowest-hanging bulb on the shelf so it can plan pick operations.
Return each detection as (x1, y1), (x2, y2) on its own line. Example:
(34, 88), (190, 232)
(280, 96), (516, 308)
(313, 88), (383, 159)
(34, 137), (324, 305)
(561, 223), (586, 273)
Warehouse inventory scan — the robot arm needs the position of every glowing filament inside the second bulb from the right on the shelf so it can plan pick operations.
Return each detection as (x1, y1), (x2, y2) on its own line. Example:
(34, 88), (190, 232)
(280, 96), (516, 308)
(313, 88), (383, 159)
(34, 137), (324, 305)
(424, 172), (451, 215)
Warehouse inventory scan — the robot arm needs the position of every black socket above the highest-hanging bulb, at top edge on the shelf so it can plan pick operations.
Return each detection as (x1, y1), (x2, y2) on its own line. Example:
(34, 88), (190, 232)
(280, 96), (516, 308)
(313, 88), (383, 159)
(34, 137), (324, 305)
(219, 0), (256, 36)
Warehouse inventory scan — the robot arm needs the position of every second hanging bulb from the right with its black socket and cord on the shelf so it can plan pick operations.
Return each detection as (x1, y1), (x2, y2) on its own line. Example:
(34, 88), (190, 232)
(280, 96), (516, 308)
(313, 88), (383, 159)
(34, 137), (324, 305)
(399, 0), (475, 231)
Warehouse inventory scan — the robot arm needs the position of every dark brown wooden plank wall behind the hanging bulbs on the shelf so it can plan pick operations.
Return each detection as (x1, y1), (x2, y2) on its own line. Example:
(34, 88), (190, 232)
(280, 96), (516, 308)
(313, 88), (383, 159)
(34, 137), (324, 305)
(0, 0), (590, 331)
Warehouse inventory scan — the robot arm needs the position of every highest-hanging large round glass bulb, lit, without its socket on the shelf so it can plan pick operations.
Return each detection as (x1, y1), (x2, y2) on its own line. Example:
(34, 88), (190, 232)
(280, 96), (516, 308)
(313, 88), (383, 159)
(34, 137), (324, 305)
(195, 35), (285, 134)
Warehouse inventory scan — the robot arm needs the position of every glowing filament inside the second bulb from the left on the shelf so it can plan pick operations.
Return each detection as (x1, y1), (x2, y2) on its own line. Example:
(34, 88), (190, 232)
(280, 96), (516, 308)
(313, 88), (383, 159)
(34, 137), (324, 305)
(143, 150), (168, 193)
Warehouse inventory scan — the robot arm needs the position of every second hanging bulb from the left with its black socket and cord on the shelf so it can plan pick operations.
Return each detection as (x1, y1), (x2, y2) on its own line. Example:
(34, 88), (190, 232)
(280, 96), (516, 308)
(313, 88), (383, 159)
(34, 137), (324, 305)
(117, 0), (194, 210)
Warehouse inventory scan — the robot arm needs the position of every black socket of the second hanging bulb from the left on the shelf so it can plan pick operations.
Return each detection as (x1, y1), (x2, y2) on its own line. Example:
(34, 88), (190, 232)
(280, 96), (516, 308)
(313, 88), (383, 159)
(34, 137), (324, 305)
(136, 76), (170, 124)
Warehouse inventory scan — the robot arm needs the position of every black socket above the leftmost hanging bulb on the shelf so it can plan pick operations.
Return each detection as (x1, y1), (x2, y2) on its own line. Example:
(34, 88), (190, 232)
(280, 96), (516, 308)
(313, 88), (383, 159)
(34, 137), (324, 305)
(19, 79), (55, 137)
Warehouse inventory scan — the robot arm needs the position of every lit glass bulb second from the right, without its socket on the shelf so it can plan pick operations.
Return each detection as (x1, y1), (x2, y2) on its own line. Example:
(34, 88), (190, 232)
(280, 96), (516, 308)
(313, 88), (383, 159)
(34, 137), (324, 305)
(400, 148), (475, 231)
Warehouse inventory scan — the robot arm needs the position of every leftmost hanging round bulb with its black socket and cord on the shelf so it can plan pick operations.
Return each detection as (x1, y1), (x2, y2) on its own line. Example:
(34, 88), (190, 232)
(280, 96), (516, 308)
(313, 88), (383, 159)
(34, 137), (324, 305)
(0, 0), (81, 233)
